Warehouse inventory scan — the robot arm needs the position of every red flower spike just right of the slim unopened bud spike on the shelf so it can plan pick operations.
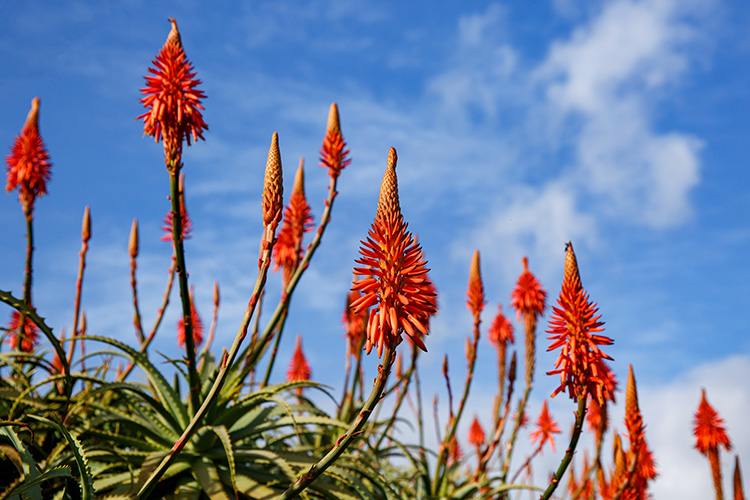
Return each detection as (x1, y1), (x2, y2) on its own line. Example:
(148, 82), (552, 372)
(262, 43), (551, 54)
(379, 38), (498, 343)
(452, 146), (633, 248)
(273, 160), (313, 283)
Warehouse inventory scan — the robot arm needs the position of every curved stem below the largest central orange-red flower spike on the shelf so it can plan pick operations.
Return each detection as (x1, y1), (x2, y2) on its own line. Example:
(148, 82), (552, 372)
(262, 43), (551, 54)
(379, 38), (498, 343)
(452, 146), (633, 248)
(276, 346), (395, 500)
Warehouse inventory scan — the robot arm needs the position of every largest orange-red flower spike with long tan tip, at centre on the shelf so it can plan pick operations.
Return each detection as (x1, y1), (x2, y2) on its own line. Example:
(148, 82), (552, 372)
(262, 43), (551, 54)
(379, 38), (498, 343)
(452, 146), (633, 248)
(351, 148), (436, 357)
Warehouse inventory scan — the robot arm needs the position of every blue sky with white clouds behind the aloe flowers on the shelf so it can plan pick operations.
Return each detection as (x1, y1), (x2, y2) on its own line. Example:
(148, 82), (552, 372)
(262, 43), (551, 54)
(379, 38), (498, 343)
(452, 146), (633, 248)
(0, 0), (750, 499)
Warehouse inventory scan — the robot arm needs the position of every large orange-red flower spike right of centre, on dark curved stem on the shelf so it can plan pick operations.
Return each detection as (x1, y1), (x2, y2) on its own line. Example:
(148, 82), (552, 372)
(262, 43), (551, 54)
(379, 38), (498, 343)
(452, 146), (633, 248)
(547, 244), (614, 404)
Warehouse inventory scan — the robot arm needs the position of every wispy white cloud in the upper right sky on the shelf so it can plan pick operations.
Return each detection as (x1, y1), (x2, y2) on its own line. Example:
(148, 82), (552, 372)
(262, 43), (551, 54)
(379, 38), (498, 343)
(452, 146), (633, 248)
(533, 0), (712, 227)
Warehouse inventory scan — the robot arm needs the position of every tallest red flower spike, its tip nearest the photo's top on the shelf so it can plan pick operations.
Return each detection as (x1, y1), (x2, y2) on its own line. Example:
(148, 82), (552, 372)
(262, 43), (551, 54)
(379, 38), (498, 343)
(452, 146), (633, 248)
(136, 18), (208, 151)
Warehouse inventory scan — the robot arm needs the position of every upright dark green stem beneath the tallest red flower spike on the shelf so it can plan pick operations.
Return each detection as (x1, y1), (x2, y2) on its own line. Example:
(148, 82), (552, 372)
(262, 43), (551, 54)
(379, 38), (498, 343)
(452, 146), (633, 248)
(169, 170), (201, 409)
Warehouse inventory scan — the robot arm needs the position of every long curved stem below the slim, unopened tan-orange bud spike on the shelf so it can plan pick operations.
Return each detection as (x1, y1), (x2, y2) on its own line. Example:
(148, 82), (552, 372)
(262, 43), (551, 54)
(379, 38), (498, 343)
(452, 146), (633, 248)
(136, 229), (274, 500)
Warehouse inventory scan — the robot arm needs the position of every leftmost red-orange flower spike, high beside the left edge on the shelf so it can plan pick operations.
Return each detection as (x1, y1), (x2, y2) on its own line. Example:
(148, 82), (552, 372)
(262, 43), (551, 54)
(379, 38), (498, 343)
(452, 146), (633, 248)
(5, 97), (52, 214)
